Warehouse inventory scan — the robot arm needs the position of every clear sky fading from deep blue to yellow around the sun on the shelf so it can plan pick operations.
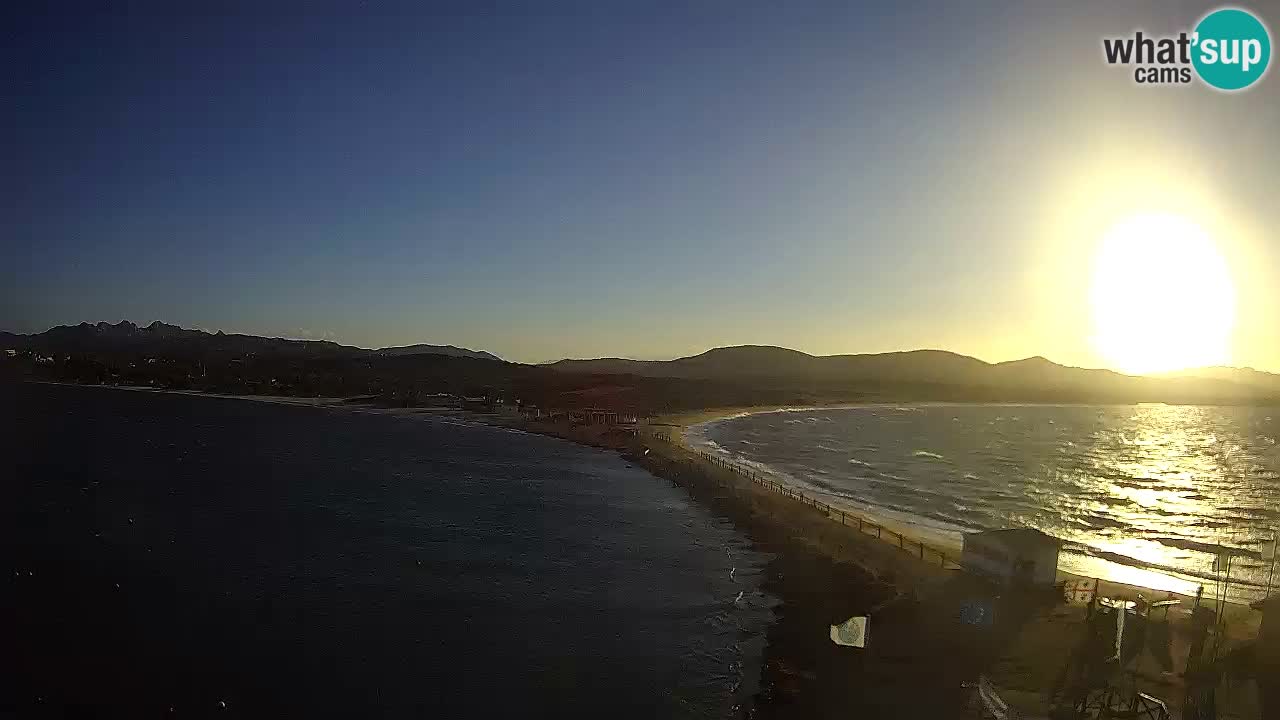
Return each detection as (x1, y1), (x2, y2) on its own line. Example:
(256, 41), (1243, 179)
(0, 0), (1280, 363)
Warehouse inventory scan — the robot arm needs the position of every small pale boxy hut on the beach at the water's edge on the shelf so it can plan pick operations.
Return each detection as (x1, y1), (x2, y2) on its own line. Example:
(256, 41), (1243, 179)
(960, 528), (1062, 585)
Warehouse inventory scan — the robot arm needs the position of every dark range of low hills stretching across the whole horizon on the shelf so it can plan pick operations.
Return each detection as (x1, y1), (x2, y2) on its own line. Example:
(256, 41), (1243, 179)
(0, 320), (1280, 407)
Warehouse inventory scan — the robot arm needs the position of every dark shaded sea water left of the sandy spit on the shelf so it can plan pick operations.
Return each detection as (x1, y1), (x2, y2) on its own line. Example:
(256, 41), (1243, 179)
(0, 386), (772, 717)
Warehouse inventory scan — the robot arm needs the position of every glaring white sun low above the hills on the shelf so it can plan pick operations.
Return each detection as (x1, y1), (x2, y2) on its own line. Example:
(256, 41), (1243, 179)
(1089, 215), (1235, 374)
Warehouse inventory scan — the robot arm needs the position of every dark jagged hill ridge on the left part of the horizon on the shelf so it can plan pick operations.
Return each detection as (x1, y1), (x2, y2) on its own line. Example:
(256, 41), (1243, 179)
(0, 320), (502, 361)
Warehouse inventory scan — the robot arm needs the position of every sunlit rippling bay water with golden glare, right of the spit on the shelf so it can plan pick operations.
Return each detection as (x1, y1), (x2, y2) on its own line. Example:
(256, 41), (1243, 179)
(690, 405), (1280, 597)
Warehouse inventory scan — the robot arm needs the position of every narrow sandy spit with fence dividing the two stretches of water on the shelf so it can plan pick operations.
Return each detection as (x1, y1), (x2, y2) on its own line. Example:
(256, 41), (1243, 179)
(30, 383), (1258, 717)
